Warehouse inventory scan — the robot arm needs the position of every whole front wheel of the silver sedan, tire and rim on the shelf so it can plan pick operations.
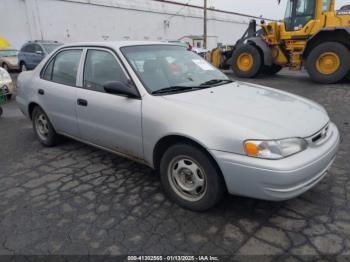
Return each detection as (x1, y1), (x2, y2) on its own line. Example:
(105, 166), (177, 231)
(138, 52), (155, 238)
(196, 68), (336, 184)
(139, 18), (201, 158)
(160, 144), (225, 211)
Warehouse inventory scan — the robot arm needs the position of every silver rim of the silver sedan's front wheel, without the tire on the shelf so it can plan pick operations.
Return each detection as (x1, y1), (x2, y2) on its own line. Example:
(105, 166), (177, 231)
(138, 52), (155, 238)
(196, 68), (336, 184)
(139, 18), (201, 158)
(168, 156), (207, 202)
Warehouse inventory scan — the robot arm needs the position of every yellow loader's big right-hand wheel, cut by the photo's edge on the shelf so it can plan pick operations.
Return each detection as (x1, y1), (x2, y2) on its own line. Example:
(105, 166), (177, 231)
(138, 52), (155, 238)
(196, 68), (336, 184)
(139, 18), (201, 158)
(306, 42), (350, 84)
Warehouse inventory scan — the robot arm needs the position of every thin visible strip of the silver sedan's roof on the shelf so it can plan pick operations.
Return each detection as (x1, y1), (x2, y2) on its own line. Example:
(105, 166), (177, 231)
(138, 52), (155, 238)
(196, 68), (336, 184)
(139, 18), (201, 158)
(62, 41), (176, 49)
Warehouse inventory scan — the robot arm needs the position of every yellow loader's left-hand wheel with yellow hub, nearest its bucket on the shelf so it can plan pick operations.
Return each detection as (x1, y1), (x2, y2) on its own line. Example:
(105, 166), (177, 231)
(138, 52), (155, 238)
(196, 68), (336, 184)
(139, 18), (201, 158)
(232, 44), (262, 78)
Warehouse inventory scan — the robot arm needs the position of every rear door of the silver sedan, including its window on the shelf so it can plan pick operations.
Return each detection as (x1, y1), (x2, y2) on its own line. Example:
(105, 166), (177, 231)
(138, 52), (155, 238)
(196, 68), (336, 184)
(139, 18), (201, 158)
(36, 48), (83, 137)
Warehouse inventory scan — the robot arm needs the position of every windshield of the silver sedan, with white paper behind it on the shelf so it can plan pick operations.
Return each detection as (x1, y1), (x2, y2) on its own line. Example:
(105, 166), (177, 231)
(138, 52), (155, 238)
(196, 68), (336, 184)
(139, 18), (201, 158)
(121, 45), (229, 93)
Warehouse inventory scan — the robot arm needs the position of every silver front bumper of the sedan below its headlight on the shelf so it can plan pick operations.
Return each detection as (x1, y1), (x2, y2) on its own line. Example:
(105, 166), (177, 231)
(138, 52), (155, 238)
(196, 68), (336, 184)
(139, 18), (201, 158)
(211, 123), (340, 201)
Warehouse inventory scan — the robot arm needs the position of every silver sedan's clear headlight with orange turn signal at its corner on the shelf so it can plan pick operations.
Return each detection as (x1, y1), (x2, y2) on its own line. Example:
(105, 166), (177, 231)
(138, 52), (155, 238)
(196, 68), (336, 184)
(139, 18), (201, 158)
(244, 138), (307, 159)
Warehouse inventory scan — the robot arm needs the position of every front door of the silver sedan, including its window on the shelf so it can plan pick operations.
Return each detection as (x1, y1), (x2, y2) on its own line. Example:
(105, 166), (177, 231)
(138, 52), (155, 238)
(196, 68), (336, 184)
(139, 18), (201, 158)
(77, 48), (143, 159)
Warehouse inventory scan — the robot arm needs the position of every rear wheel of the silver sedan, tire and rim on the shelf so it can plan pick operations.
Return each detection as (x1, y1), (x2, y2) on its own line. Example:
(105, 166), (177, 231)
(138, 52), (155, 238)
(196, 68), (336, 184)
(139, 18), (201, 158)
(32, 106), (59, 147)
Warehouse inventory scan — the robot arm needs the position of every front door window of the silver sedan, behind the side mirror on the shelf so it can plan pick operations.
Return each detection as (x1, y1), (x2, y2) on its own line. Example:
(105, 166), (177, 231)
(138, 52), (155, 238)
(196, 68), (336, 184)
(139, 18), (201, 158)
(84, 50), (127, 92)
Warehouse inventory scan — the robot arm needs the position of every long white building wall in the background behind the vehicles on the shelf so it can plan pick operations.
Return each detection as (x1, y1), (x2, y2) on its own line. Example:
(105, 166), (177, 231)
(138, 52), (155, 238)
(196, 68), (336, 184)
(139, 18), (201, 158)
(0, 0), (268, 48)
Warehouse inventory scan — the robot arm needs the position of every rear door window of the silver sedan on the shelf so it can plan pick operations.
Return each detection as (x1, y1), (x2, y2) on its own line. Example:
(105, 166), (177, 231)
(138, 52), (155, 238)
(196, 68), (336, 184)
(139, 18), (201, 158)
(43, 49), (82, 86)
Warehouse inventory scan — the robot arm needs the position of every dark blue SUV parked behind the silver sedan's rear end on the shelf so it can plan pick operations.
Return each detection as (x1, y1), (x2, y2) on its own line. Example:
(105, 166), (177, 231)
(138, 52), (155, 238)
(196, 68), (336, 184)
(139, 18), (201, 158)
(18, 40), (62, 71)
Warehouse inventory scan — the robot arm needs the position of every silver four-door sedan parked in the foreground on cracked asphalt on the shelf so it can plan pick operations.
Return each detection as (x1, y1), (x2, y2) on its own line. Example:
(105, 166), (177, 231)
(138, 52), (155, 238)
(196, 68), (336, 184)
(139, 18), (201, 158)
(16, 41), (339, 211)
